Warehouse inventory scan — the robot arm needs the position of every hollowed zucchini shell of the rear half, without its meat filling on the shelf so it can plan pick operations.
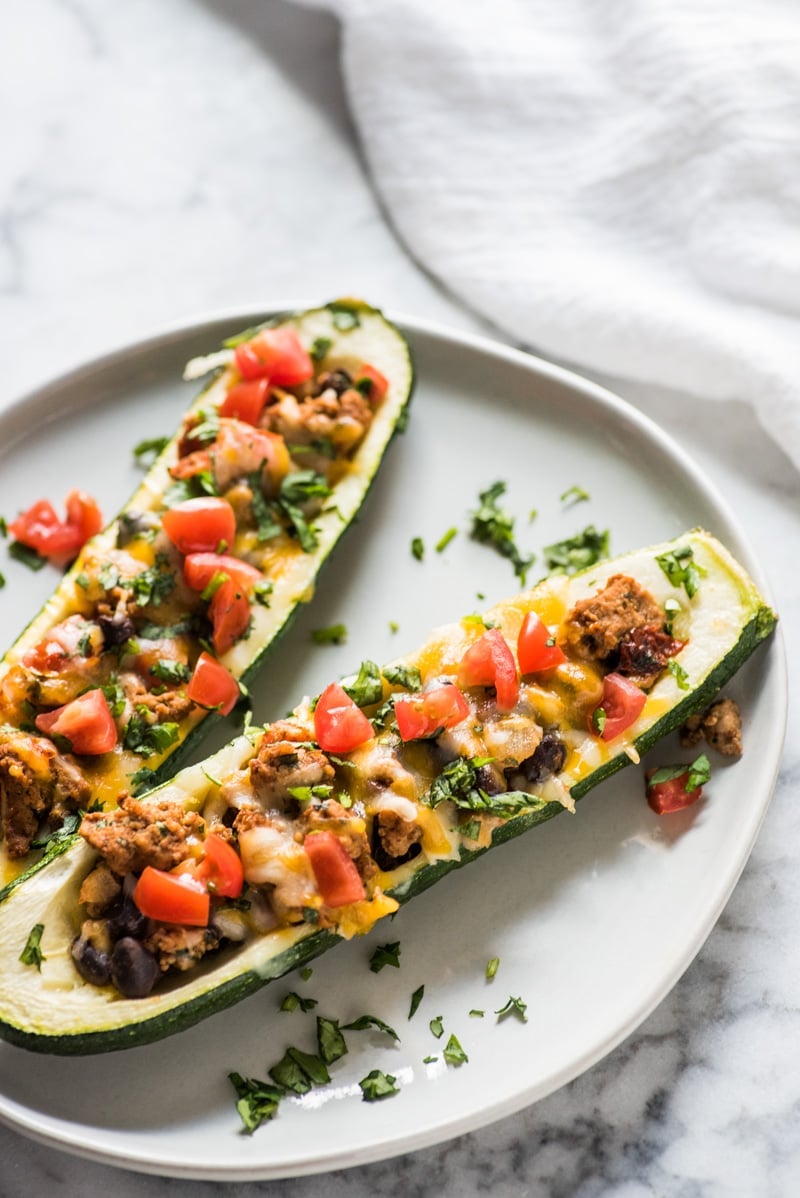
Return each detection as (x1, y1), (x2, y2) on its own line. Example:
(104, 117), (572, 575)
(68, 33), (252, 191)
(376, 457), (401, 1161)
(0, 301), (413, 888)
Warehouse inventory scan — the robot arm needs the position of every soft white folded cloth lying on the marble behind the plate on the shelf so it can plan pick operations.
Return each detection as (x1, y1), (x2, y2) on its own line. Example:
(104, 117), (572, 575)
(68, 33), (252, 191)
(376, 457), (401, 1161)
(291, 0), (800, 467)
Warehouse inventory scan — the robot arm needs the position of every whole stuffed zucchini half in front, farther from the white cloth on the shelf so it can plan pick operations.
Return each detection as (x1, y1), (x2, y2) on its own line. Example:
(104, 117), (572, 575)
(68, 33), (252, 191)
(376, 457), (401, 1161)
(0, 531), (776, 1054)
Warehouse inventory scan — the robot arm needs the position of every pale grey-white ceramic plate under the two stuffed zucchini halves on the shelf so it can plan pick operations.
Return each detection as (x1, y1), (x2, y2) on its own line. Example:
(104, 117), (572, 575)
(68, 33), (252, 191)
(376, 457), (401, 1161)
(0, 311), (786, 1180)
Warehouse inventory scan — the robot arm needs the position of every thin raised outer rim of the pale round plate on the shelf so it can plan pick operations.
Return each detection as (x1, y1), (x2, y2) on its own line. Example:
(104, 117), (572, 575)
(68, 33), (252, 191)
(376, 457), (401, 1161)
(0, 302), (788, 1181)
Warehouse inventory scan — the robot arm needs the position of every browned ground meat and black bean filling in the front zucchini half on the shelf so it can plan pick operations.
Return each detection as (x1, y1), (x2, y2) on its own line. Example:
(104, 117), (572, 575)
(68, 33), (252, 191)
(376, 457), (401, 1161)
(72, 574), (694, 997)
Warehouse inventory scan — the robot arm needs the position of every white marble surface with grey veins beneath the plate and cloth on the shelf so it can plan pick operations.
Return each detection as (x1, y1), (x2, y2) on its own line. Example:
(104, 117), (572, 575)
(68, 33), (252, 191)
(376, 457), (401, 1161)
(0, 0), (800, 1198)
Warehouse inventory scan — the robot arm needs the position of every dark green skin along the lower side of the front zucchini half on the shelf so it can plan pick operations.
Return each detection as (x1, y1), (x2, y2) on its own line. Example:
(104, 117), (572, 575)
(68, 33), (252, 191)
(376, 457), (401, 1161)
(0, 534), (777, 1055)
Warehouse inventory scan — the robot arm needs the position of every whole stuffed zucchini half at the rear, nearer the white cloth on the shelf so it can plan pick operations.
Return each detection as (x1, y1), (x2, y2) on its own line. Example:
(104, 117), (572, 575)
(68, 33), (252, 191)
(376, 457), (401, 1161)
(0, 301), (413, 893)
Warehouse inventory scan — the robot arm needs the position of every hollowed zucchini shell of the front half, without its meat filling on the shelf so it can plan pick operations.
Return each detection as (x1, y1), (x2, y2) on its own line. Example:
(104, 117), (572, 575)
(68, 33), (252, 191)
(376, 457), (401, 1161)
(0, 530), (776, 1054)
